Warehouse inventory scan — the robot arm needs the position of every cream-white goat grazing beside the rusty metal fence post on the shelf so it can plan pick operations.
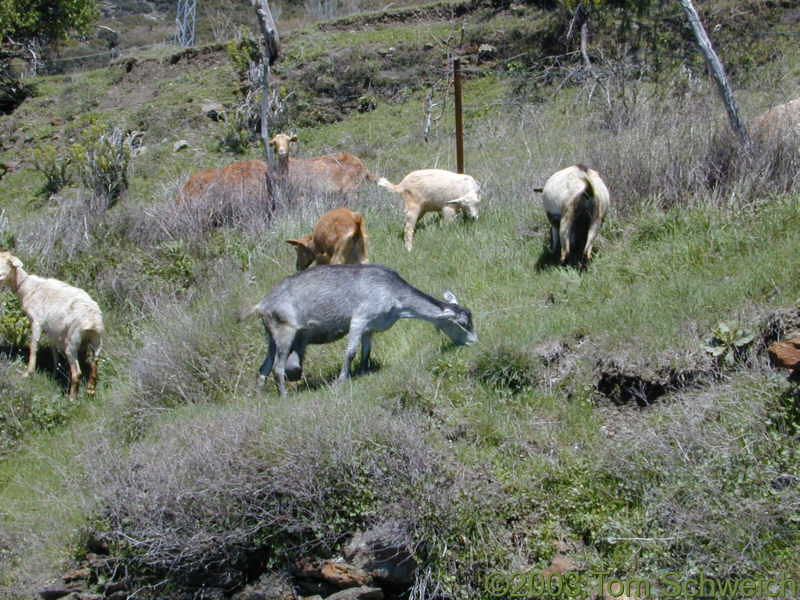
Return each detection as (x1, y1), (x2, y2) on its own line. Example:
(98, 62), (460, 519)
(378, 169), (481, 250)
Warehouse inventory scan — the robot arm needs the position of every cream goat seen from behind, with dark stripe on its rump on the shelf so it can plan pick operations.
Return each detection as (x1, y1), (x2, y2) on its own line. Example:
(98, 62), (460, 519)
(541, 165), (610, 266)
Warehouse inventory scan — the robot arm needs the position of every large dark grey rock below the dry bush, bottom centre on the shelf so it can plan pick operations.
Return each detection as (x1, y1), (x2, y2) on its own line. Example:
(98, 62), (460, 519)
(343, 526), (417, 588)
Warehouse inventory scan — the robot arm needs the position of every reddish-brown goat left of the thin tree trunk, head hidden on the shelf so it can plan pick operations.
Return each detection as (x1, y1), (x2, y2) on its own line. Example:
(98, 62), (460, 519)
(176, 160), (269, 204)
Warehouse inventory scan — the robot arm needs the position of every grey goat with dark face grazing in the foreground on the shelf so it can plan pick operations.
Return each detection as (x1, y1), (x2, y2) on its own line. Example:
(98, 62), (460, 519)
(237, 264), (478, 396)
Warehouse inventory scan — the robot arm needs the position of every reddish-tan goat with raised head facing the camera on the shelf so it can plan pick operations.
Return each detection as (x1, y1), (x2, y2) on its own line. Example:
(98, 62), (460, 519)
(269, 133), (375, 199)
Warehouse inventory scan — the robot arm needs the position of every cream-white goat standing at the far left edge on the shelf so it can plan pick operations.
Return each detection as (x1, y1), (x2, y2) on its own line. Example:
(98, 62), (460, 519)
(0, 252), (103, 399)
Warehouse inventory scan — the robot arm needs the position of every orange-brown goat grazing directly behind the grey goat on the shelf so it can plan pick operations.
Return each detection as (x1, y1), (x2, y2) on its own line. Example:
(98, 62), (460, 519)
(286, 208), (369, 271)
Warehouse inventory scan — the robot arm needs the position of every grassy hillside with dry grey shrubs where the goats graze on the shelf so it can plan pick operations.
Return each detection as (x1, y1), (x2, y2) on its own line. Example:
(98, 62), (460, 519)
(0, 1), (800, 599)
